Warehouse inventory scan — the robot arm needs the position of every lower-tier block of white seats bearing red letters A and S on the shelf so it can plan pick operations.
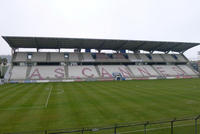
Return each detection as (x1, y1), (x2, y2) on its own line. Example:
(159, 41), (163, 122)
(29, 66), (66, 80)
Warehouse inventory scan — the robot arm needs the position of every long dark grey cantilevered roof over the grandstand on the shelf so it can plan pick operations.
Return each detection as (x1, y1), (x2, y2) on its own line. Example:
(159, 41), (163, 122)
(3, 36), (200, 52)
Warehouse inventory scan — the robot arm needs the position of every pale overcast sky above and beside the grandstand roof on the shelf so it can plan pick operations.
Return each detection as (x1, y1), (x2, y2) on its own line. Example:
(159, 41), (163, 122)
(0, 0), (200, 59)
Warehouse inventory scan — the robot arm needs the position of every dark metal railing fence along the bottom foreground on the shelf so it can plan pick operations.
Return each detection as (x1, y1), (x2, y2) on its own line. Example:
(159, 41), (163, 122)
(4, 115), (200, 134)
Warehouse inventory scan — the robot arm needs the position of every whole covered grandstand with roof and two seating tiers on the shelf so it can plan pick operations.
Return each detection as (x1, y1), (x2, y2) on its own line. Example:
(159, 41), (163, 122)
(3, 36), (199, 83)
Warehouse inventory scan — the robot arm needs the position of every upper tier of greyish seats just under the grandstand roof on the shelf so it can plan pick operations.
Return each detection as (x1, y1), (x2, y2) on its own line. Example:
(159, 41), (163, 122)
(13, 52), (187, 62)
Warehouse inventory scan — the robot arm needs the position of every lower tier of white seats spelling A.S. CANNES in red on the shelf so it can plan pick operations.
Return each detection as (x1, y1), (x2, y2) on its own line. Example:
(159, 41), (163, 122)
(10, 65), (198, 80)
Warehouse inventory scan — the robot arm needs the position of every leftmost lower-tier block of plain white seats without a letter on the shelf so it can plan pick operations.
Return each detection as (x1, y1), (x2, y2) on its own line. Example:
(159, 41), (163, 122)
(10, 66), (27, 80)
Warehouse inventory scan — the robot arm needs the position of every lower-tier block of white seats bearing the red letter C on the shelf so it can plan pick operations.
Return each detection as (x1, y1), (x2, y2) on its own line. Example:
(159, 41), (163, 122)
(68, 66), (99, 78)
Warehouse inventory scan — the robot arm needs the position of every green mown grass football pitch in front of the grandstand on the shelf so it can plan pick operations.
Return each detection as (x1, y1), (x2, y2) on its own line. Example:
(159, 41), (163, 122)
(0, 79), (200, 134)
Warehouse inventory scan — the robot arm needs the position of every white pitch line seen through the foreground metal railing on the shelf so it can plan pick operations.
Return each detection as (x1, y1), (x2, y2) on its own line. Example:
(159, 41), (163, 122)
(117, 123), (194, 134)
